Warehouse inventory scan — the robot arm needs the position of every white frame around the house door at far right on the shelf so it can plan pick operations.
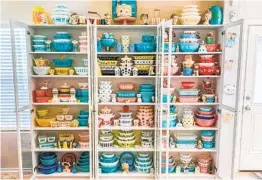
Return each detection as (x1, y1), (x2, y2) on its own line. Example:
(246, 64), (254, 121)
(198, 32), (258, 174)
(232, 19), (262, 175)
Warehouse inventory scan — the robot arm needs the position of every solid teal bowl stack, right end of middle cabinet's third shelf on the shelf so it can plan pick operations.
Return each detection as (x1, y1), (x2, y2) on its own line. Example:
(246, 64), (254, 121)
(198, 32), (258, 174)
(139, 84), (155, 103)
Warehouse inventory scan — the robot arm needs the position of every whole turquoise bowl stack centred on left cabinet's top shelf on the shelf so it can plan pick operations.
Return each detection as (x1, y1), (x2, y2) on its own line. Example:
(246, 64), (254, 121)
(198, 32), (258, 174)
(52, 32), (73, 52)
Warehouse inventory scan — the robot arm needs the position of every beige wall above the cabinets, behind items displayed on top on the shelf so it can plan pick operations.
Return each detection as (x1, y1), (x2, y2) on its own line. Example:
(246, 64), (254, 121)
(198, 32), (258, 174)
(1, 0), (223, 24)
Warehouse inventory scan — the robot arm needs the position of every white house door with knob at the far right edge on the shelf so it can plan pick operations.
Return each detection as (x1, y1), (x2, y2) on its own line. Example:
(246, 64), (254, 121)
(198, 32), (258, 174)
(240, 26), (262, 170)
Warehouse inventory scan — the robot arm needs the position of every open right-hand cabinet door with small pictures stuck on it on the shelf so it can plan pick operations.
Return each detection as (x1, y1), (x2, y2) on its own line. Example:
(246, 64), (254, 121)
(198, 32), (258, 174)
(217, 20), (243, 179)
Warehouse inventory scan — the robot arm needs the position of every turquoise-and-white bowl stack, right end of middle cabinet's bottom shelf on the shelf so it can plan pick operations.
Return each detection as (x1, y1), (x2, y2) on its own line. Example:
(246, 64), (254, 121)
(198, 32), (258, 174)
(135, 153), (153, 173)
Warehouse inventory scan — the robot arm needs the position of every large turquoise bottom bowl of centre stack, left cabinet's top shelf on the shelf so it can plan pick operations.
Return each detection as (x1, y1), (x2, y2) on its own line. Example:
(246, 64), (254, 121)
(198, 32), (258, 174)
(52, 39), (73, 52)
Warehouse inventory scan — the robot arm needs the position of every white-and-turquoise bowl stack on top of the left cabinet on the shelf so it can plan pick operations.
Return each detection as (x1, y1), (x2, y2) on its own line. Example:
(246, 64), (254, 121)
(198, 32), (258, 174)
(52, 4), (71, 25)
